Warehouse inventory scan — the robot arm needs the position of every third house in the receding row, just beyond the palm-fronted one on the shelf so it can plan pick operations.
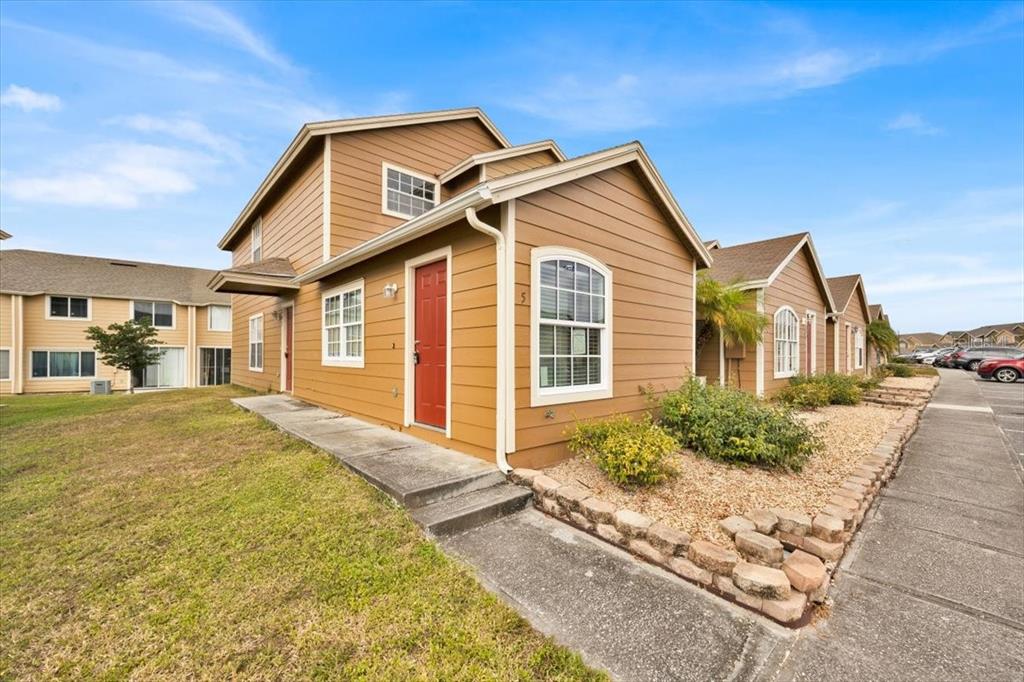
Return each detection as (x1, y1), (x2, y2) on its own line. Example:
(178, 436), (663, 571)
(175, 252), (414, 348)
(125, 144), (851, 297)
(825, 274), (871, 375)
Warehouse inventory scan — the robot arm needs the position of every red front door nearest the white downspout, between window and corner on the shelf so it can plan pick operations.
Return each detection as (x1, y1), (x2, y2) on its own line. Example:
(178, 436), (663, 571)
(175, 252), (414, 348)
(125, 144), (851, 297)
(413, 260), (447, 428)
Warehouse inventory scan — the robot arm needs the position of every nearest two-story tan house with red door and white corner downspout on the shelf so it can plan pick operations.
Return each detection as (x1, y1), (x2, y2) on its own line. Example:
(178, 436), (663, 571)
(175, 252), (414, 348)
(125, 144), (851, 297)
(211, 109), (711, 468)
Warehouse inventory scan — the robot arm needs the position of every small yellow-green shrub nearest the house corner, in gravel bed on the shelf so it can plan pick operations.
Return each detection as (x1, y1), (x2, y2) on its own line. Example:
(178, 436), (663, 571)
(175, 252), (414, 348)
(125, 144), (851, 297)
(568, 415), (679, 485)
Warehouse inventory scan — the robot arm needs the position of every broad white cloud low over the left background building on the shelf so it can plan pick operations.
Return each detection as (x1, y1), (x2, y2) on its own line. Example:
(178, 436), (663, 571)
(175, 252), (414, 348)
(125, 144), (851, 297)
(2, 143), (214, 209)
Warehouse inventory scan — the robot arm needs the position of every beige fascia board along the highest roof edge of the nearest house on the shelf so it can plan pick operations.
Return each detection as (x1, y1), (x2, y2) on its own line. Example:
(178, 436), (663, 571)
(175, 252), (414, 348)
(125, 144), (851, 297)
(217, 108), (512, 250)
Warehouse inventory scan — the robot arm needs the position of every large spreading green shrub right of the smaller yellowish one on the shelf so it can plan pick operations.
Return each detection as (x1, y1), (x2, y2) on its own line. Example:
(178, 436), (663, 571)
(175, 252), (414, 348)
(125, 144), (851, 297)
(662, 380), (818, 471)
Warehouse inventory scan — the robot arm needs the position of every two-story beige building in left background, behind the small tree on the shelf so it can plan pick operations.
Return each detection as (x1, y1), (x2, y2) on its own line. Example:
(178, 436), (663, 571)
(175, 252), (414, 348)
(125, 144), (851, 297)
(0, 249), (231, 393)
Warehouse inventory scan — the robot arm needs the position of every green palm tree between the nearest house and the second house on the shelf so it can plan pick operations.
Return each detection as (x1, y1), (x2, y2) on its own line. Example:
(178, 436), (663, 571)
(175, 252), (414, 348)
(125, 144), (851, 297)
(696, 271), (769, 357)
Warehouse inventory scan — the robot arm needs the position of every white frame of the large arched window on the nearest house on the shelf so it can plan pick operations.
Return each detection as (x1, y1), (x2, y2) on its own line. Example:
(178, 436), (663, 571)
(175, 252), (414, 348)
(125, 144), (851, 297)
(529, 247), (614, 408)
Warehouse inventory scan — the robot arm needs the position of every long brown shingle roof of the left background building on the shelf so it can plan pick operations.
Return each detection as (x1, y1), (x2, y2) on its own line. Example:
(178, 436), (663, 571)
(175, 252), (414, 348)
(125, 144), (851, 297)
(0, 249), (231, 305)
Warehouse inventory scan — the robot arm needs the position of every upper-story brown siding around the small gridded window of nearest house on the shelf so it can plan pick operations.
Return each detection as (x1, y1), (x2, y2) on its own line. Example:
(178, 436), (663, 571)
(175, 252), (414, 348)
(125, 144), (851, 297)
(331, 119), (502, 255)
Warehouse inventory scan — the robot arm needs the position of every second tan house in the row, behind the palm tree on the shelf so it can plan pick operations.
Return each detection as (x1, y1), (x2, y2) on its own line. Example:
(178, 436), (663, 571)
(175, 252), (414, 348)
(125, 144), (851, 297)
(697, 232), (835, 395)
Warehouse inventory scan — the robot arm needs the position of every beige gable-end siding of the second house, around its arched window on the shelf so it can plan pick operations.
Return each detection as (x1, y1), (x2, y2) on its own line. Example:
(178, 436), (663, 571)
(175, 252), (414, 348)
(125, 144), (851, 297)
(761, 247), (827, 396)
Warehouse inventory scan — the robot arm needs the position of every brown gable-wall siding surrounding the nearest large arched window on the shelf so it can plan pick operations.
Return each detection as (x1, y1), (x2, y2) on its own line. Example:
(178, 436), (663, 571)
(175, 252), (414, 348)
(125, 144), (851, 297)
(510, 163), (694, 466)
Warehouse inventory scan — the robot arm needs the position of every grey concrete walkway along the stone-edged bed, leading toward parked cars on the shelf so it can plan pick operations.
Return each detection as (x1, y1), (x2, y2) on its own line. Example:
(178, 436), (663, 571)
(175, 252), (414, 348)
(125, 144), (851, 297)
(765, 370), (1024, 680)
